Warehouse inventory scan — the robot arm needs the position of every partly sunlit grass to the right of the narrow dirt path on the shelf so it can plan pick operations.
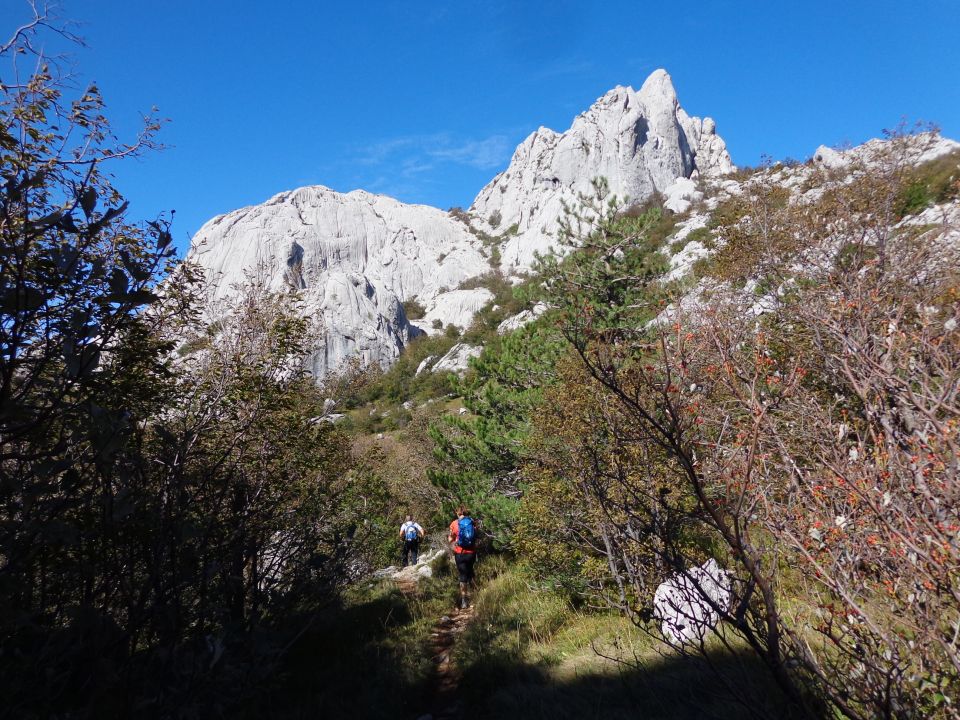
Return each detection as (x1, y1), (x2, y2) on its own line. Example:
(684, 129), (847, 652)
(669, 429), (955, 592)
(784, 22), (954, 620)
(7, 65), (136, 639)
(455, 566), (800, 720)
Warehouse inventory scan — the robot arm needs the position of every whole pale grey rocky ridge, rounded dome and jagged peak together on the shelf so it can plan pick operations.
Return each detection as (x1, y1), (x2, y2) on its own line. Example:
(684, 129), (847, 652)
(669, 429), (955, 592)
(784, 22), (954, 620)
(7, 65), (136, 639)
(188, 70), (733, 377)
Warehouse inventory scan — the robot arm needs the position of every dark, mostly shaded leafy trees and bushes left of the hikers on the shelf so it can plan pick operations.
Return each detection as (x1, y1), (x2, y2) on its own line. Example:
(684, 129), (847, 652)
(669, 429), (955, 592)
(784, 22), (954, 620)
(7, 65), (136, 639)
(0, 16), (380, 718)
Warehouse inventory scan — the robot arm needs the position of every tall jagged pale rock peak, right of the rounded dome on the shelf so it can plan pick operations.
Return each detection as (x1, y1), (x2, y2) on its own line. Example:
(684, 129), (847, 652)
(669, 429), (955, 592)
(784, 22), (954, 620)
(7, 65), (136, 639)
(470, 70), (734, 270)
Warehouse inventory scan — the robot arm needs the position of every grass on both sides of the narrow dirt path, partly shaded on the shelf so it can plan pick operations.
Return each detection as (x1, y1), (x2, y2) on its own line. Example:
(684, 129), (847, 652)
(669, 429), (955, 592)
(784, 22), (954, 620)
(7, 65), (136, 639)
(241, 555), (808, 720)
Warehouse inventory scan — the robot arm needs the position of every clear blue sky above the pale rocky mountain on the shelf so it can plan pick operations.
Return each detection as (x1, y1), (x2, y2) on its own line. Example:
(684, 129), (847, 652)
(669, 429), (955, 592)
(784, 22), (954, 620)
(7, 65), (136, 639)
(9, 0), (960, 249)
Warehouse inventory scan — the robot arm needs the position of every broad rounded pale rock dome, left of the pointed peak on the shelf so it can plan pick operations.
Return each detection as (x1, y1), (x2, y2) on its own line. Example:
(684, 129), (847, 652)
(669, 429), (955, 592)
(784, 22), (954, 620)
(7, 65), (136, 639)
(188, 186), (490, 377)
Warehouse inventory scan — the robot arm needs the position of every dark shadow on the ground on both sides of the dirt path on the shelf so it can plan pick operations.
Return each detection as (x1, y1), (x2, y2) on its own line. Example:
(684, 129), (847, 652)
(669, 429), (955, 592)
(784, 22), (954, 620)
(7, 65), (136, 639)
(244, 585), (808, 720)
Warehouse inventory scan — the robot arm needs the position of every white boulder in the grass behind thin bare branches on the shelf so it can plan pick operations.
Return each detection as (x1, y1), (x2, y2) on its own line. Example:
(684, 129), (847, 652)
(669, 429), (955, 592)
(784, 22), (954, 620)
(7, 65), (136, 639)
(653, 558), (732, 645)
